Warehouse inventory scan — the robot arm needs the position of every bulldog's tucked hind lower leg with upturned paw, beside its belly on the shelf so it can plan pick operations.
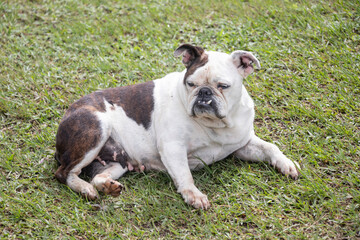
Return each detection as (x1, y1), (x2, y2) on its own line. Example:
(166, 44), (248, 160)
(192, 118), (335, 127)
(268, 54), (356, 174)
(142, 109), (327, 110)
(91, 162), (128, 197)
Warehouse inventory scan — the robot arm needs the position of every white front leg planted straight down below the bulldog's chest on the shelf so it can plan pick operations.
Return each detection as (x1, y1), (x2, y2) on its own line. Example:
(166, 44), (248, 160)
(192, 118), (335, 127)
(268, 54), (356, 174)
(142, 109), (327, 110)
(160, 143), (210, 209)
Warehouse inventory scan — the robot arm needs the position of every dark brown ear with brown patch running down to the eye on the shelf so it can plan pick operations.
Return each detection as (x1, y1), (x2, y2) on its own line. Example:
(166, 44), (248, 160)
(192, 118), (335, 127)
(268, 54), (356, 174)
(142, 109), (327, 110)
(174, 44), (209, 83)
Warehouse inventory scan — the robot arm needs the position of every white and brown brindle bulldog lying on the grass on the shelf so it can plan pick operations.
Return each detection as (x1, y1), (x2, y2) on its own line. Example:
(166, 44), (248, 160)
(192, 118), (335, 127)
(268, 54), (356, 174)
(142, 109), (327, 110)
(55, 44), (299, 209)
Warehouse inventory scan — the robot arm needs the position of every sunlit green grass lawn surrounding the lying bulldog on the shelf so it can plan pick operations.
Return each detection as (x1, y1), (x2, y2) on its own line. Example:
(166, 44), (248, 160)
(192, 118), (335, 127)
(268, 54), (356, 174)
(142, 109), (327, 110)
(0, 0), (360, 239)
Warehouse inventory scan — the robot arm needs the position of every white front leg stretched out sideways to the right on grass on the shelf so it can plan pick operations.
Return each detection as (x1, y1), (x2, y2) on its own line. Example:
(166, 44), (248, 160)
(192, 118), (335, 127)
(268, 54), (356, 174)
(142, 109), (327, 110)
(235, 135), (300, 179)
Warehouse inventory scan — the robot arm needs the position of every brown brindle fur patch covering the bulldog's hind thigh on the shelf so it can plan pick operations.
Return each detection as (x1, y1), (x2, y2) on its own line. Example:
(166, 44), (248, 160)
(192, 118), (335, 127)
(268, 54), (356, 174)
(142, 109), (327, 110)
(55, 108), (101, 183)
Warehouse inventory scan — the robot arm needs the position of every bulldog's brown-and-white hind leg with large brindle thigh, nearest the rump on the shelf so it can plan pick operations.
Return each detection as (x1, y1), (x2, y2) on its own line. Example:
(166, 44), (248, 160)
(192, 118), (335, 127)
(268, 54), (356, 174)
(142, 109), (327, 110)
(55, 108), (110, 200)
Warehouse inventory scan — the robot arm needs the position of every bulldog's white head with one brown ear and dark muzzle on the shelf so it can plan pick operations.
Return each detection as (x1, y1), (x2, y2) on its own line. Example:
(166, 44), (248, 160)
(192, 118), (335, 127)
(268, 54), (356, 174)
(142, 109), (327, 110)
(174, 44), (260, 124)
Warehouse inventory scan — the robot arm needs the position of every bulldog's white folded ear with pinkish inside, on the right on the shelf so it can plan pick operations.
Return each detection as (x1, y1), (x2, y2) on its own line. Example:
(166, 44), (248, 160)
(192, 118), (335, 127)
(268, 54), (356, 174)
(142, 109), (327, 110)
(231, 51), (260, 78)
